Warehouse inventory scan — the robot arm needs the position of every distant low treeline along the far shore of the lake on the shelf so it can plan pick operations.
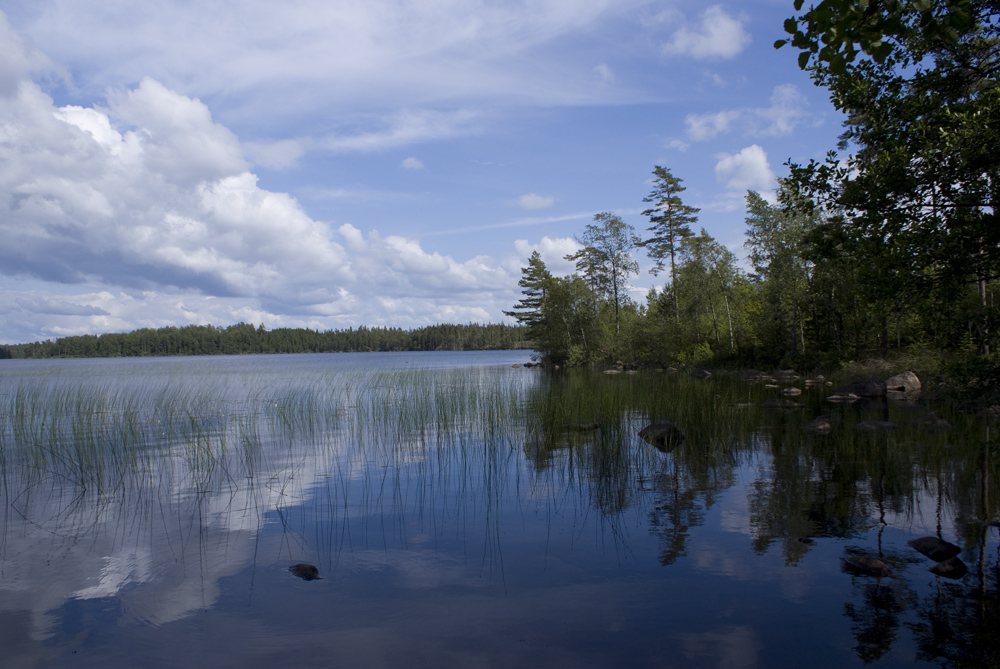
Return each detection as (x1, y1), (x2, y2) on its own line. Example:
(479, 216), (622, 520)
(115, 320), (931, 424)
(0, 323), (531, 359)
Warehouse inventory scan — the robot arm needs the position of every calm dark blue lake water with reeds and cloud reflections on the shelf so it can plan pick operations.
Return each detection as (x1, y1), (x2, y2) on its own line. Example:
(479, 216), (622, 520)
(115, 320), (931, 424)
(0, 351), (1000, 668)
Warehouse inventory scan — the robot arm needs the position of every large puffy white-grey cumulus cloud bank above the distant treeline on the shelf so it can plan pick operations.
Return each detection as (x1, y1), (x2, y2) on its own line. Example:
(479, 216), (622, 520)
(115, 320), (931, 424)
(0, 18), (545, 342)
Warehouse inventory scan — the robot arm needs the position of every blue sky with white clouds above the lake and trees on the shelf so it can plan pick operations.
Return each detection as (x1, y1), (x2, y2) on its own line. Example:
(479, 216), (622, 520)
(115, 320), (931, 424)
(0, 0), (842, 344)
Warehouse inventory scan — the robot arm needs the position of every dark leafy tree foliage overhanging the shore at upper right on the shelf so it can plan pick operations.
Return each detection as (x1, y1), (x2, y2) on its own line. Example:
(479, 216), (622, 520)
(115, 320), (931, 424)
(785, 0), (1000, 353)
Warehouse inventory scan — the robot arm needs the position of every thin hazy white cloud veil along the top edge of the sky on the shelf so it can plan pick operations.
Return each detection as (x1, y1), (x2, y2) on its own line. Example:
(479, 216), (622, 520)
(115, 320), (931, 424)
(13, 0), (648, 120)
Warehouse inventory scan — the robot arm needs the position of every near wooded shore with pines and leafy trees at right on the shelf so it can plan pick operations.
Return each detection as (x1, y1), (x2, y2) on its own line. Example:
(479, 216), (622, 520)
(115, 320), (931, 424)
(507, 0), (1000, 378)
